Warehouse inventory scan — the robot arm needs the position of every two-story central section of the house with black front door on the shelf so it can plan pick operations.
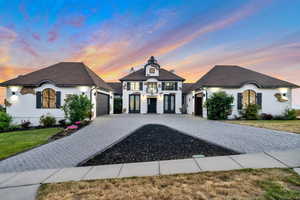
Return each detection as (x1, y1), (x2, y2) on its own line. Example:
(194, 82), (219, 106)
(120, 56), (185, 114)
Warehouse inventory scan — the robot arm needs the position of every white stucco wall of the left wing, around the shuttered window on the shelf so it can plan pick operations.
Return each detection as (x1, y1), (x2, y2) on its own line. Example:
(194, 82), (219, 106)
(6, 83), (113, 125)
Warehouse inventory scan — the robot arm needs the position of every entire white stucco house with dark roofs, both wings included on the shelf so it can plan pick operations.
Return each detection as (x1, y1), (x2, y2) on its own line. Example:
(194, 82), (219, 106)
(0, 56), (299, 125)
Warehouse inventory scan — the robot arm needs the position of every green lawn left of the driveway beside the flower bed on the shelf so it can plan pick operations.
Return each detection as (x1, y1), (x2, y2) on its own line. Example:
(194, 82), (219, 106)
(0, 128), (62, 159)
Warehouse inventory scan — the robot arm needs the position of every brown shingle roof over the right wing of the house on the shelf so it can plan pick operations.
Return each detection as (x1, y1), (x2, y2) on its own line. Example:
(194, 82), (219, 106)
(192, 65), (299, 90)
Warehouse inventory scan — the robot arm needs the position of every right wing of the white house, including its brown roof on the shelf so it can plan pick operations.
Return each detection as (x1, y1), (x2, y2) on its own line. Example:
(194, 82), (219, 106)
(186, 65), (299, 118)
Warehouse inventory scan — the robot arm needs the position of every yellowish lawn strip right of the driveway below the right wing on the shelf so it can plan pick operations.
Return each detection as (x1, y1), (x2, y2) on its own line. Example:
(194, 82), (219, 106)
(225, 120), (300, 134)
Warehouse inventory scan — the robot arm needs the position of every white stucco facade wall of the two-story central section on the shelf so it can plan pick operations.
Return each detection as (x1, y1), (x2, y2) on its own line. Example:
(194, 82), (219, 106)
(122, 78), (182, 114)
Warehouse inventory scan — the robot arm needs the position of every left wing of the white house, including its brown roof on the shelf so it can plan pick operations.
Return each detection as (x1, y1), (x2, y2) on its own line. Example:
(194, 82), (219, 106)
(0, 62), (113, 125)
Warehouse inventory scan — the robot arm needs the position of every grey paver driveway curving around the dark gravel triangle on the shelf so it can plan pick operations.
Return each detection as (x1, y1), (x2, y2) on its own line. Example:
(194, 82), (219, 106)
(0, 114), (300, 173)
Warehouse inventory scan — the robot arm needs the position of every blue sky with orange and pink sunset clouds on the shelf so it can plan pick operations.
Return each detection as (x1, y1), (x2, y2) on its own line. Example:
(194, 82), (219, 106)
(0, 0), (300, 105)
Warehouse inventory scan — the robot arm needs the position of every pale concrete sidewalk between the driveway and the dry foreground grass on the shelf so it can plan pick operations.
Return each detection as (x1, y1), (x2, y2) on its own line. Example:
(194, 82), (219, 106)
(0, 148), (300, 200)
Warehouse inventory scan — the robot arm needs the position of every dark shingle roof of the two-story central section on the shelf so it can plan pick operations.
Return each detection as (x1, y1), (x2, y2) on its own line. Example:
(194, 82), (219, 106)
(120, 68), (185, 81)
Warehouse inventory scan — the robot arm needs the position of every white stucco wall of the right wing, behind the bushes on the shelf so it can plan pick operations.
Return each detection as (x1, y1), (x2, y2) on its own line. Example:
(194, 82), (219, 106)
(187, 84), (292, 118)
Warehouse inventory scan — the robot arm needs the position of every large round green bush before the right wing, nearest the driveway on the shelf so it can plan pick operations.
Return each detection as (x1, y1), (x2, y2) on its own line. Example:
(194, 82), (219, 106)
(205, 92), (234, 120)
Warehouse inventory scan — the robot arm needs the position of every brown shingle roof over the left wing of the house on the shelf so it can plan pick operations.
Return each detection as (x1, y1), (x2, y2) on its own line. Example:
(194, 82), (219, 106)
(0, 62), (112, 90)
